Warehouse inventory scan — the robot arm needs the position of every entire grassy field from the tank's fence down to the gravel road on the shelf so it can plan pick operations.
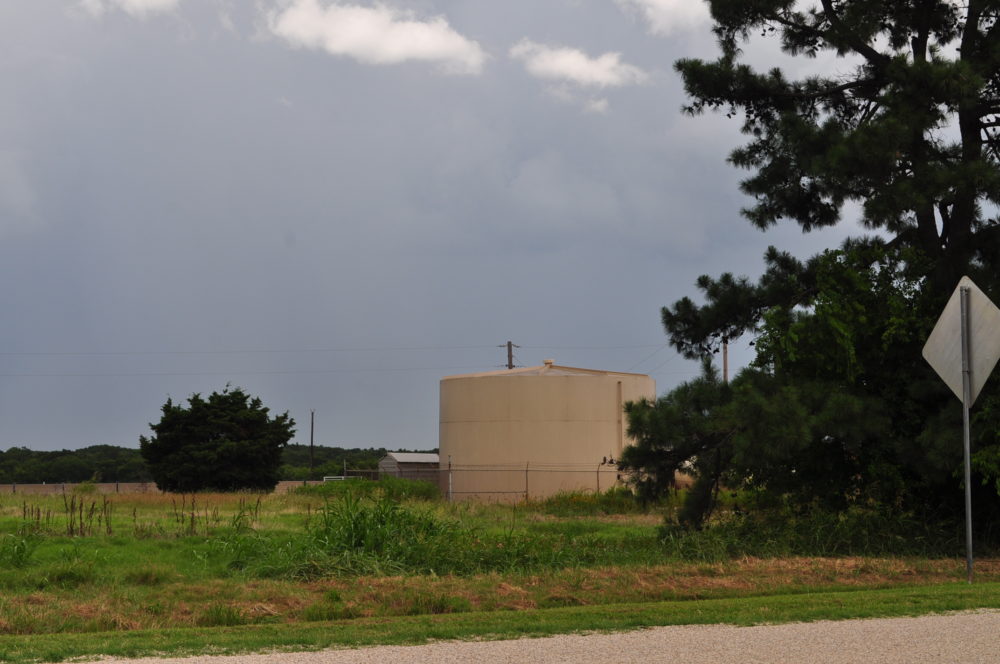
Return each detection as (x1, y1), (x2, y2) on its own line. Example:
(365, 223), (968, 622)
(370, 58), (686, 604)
(0, 485), (1000, 661)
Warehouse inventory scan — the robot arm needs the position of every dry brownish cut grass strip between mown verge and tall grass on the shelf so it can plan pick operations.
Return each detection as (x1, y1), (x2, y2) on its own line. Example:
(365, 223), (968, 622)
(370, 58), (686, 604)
(0, 558), (1000, 634)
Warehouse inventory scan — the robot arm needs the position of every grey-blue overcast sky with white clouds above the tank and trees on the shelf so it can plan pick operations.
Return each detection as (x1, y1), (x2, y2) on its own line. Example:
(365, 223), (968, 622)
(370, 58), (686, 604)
(0, 0), (852, 450)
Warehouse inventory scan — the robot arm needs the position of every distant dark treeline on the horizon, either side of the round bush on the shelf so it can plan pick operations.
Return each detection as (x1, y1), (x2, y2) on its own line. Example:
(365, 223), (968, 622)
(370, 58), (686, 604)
(0, 445), (438, 484)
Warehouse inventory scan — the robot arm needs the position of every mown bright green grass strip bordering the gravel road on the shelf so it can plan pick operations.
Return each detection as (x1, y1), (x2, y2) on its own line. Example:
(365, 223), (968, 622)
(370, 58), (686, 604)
(0, 583), (1000, 662)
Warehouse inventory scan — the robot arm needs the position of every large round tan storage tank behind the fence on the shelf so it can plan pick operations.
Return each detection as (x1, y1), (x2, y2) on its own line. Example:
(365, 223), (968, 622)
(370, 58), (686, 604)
(439, 360), (656, 501)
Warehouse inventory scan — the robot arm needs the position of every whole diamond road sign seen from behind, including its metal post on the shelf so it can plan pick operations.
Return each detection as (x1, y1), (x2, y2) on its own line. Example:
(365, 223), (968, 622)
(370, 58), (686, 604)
(923, 277), (1000, 583)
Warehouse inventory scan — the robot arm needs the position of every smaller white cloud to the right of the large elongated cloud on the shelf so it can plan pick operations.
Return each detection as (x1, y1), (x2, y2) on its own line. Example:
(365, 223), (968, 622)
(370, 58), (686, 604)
(510, 39), (648, 88)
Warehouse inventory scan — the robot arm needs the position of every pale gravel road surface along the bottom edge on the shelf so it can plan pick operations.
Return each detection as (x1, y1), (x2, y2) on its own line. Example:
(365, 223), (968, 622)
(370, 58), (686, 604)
(102, 611), (1000, 664)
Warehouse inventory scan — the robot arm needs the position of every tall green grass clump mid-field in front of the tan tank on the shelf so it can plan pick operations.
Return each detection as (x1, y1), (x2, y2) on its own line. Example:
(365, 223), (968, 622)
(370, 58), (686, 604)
(215, 493), (662, 578)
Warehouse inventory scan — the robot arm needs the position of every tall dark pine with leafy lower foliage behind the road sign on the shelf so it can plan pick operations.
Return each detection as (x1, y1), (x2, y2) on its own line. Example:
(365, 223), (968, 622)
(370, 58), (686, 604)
(630, 0), (1000, 524)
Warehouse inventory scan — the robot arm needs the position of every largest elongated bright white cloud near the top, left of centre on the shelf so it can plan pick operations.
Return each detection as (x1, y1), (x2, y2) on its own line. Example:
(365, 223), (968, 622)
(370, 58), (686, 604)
(268, 0), (486, 74)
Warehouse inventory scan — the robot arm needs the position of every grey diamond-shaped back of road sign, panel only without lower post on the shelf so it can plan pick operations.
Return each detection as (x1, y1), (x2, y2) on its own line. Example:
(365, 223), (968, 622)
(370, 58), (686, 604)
(923, 277), (1000, 408)
